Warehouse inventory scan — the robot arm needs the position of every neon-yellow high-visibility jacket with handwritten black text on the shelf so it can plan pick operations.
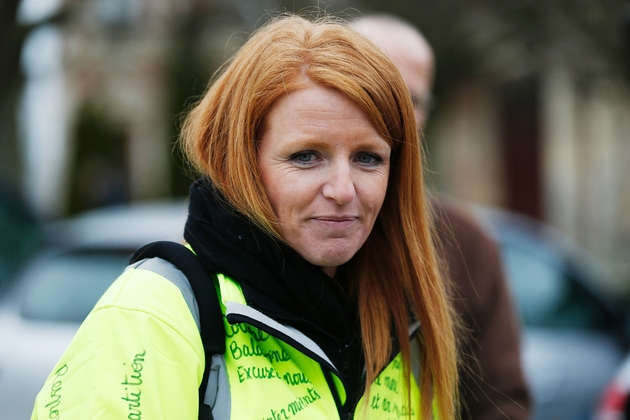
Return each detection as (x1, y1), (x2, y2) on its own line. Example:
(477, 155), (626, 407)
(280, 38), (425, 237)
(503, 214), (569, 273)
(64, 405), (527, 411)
(32, 258), (421, 420)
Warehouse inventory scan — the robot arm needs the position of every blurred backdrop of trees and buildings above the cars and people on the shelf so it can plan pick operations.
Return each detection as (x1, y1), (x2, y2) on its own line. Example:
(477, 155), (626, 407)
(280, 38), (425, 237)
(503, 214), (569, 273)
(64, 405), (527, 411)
(0, 0), (630, 419)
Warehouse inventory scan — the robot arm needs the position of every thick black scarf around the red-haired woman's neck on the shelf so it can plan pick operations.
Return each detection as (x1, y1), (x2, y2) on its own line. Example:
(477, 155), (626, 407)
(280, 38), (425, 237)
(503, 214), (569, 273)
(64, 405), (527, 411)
(184, 180), (362, 406)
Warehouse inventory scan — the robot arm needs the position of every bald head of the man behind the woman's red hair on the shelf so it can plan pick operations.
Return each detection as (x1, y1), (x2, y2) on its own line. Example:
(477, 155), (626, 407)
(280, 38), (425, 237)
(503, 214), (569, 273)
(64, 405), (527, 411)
(351, 15), (434, 128)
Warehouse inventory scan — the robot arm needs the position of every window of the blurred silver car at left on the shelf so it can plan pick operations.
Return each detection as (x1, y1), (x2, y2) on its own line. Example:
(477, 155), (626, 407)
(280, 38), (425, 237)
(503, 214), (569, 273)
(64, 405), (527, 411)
(21, 251), (129, 322)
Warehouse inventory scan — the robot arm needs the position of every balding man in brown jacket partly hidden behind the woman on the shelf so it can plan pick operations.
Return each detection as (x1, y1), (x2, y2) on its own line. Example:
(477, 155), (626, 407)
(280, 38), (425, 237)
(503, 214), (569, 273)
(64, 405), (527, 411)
(351, 15), (531, 420)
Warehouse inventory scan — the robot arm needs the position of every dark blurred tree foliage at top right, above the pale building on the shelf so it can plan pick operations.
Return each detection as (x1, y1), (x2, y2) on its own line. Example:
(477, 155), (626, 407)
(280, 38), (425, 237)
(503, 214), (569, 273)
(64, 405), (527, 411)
(362, 0), (628, 95)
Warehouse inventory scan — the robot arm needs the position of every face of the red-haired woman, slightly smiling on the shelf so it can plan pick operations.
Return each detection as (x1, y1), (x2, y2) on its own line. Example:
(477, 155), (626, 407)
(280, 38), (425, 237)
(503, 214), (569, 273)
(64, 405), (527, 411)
(258, 84), (391, 276)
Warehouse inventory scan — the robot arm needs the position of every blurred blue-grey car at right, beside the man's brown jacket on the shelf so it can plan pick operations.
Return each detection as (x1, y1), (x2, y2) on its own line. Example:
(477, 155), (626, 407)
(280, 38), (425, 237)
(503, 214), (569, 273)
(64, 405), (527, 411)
(479, 209), (628, 420)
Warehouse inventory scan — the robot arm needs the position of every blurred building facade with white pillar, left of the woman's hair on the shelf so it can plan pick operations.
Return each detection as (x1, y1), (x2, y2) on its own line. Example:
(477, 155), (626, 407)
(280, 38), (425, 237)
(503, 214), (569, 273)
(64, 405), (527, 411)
(18, 0), (324, 219)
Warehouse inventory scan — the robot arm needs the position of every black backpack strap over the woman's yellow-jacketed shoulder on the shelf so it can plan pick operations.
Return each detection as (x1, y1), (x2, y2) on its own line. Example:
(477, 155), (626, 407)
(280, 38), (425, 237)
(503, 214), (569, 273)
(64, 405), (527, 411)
(130, 241), (225, 420)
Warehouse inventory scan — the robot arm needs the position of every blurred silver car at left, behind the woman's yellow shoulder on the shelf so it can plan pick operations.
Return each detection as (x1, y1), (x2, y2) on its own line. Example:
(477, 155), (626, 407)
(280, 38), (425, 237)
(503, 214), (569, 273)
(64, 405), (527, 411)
(0, 201), (187, 420)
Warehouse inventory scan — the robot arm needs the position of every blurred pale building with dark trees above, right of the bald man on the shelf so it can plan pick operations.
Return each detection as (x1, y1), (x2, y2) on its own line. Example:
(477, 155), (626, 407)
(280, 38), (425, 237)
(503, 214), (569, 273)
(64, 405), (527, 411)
(402, 0), (630, 292)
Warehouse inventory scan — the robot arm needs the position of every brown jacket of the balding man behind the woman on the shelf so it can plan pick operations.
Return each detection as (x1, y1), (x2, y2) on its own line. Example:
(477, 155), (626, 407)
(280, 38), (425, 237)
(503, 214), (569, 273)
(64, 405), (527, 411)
(433, 197), (530, 420)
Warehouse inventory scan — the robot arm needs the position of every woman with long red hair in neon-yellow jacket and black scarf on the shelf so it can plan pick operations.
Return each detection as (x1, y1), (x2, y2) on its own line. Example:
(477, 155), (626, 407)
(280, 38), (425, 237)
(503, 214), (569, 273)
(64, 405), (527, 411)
(33, 16), (457, 419)
